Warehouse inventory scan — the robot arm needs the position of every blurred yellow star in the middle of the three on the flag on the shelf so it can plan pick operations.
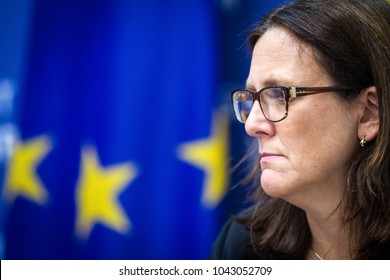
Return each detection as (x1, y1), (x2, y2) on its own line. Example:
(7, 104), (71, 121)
(76, 147), (137, 239)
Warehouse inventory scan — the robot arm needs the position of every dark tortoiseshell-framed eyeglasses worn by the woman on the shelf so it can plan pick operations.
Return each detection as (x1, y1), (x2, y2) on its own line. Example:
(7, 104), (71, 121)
(232, 86), (360, 123)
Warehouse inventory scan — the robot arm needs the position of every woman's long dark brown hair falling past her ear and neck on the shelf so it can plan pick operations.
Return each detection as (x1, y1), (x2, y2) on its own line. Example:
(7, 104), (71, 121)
(240, 0), (390, 259)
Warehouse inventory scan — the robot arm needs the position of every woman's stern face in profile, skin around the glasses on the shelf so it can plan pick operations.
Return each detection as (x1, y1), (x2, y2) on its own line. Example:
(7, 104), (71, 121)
(245, 28), (359, 208)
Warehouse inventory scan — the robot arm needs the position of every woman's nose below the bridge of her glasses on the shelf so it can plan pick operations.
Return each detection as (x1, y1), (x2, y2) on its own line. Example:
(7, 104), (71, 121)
(245, 101), (275, 137)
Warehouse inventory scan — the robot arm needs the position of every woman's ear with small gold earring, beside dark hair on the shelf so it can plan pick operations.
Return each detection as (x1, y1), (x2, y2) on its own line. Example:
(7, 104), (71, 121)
(357, 86), (379, 142)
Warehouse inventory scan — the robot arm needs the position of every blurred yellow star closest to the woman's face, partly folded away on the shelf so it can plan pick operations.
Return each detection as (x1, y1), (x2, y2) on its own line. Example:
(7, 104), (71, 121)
(178, 107), (229, 208)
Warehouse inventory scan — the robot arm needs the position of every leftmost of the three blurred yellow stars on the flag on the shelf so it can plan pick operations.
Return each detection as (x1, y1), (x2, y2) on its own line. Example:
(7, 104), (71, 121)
(4, 136), (52, 205)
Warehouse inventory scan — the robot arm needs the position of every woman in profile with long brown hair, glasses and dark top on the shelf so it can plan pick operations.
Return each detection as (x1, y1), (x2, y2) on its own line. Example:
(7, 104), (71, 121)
(211, 0), (390, 259)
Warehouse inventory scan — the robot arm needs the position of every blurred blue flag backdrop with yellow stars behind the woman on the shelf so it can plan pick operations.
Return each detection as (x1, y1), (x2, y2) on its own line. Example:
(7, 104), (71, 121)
(0, 0), (282, 259)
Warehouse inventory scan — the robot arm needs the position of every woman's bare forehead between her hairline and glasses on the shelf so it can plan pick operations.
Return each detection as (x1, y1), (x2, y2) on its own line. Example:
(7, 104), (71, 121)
(247, 27), (330, 89)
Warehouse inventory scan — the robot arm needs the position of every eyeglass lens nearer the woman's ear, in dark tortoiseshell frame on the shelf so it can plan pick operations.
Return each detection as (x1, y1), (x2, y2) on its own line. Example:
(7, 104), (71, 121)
(260, 88), (287, 122)
